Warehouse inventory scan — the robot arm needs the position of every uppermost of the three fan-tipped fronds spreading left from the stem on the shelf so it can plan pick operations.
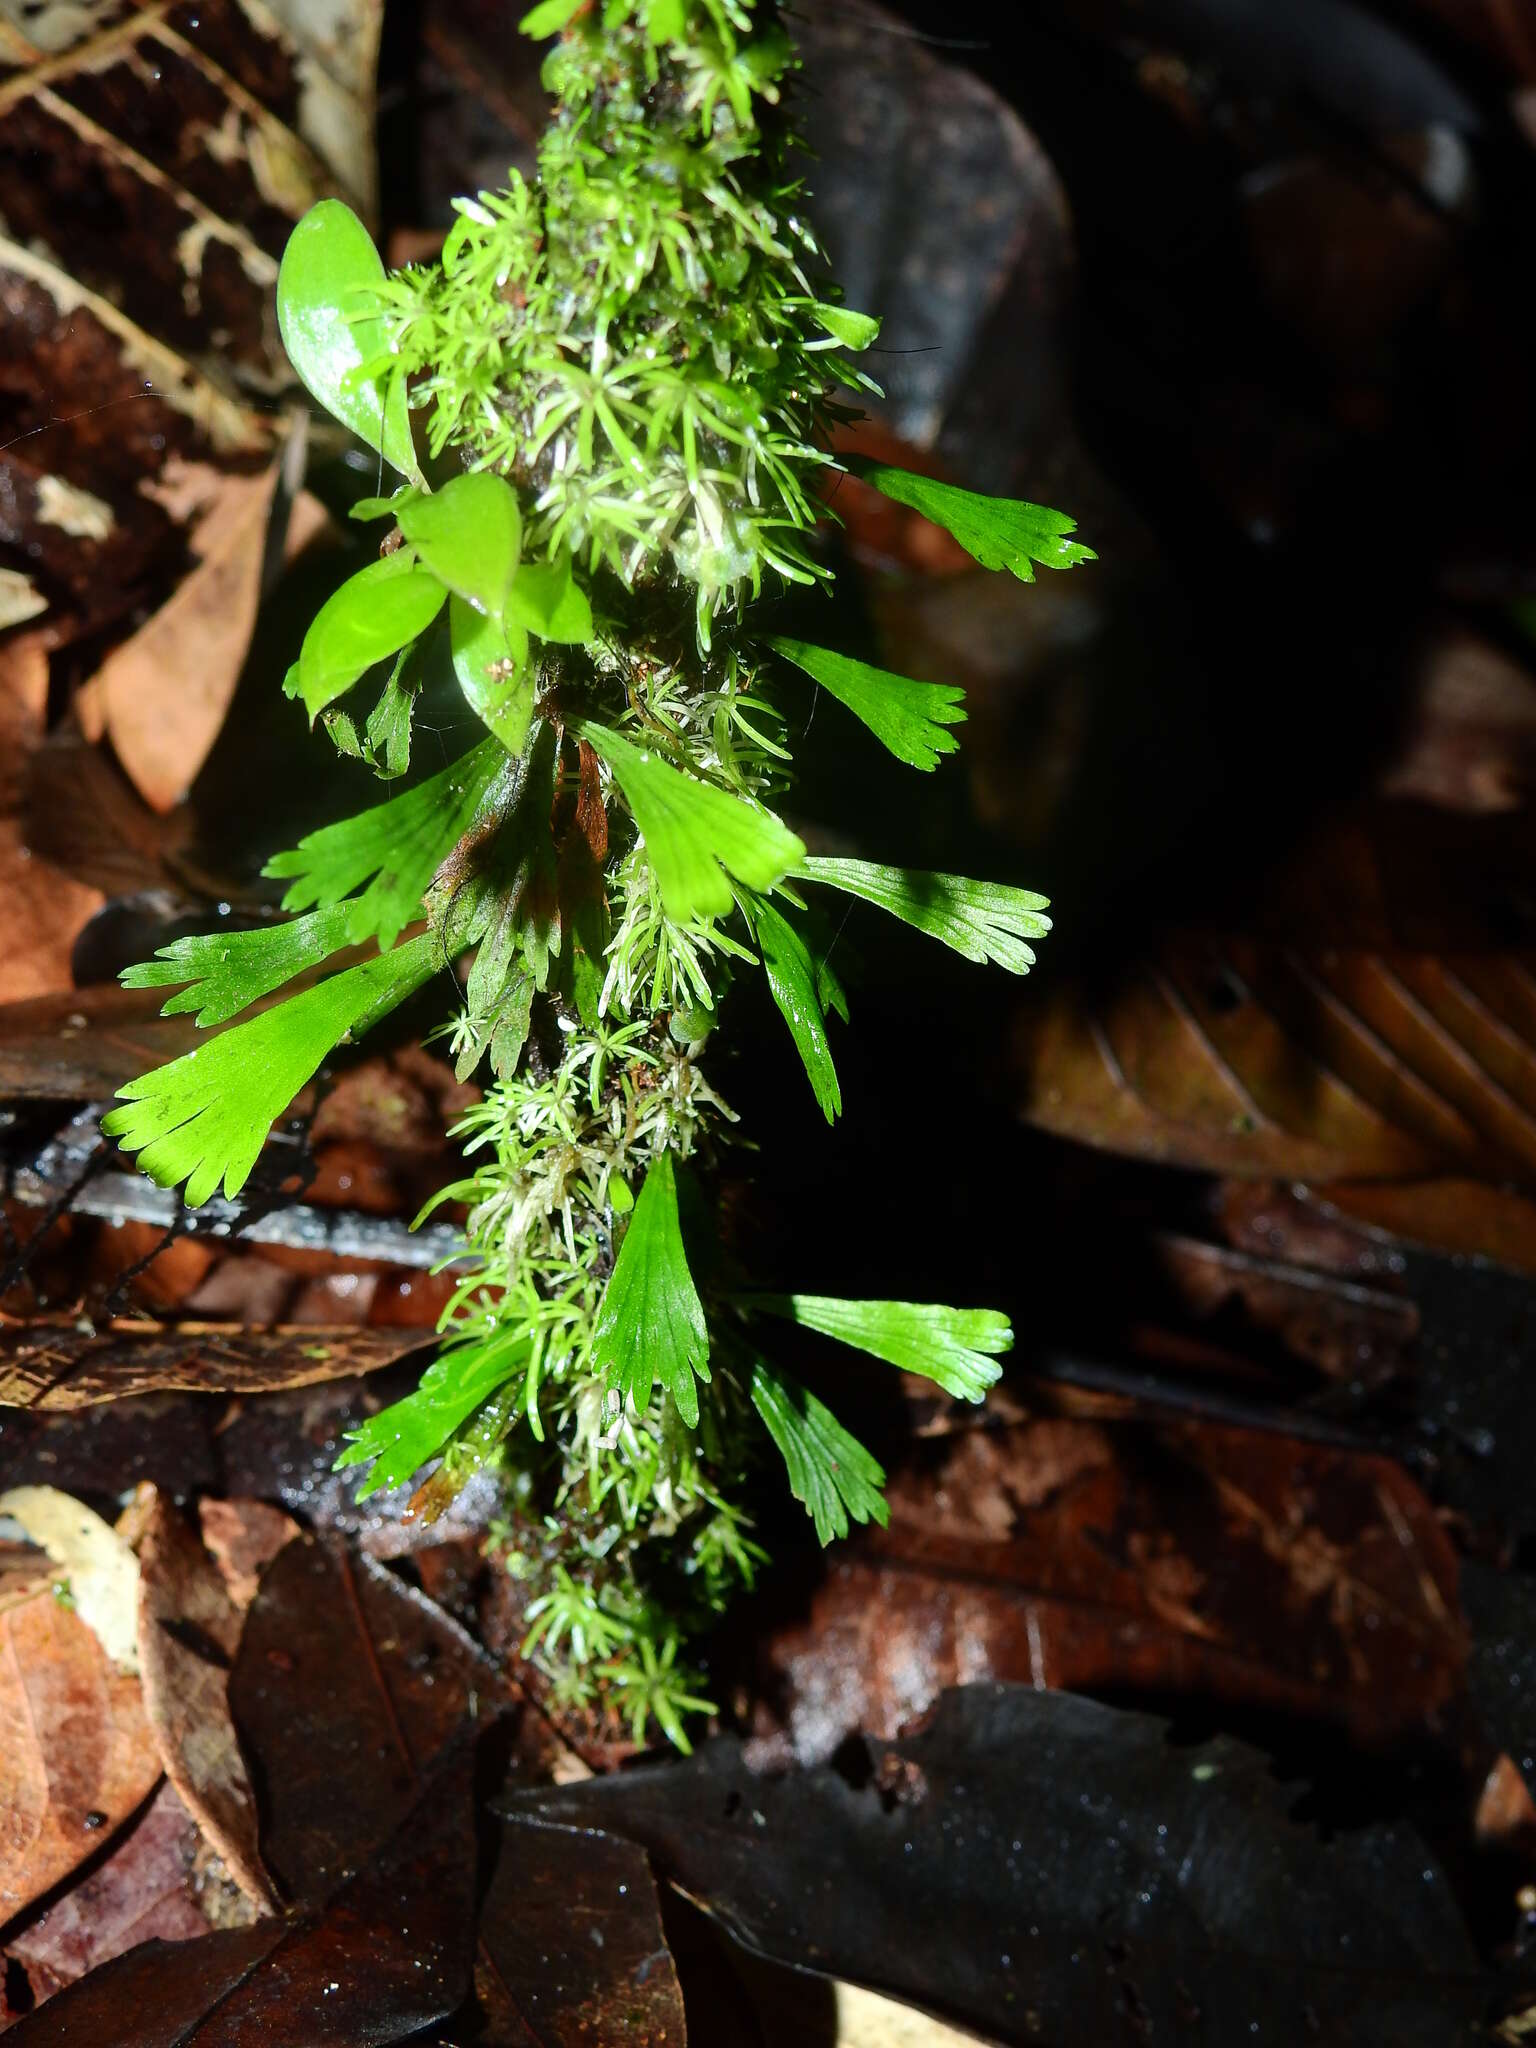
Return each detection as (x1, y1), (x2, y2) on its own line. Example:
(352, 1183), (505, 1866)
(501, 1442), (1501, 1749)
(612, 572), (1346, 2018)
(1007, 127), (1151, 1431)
(264, 739), (512, 946)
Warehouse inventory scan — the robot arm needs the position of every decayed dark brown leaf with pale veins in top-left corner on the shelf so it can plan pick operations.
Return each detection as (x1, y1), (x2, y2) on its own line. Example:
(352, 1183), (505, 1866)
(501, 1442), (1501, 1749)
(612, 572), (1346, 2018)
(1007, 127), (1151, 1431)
(0, 0), (381, 663)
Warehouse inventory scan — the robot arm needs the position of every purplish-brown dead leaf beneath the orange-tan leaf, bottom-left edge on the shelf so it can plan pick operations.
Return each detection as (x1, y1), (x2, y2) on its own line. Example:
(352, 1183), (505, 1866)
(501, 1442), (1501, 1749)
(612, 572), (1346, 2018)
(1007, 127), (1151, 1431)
(4, 1784), (227, 2005)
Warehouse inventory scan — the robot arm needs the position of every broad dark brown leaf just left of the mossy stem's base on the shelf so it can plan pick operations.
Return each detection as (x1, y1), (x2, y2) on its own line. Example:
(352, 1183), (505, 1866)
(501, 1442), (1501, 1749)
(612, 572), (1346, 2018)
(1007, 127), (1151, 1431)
(229, 1538), (510, 1898)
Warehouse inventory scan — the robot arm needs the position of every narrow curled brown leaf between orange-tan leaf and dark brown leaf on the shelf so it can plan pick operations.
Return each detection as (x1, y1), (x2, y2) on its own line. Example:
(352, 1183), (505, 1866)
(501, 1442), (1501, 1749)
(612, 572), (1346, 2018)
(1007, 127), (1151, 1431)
(139, 1495), (272, 1907)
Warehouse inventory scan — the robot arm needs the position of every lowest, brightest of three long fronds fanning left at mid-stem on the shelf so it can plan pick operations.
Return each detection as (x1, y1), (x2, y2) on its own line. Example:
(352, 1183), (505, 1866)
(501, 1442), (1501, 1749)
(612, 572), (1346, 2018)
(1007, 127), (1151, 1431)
(102, 932), (438, 1208)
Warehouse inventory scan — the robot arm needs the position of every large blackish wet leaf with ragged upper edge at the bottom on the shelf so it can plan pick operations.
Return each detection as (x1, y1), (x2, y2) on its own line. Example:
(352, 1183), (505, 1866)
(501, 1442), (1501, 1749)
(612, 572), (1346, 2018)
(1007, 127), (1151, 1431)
(514, 1686), (1501, 2048)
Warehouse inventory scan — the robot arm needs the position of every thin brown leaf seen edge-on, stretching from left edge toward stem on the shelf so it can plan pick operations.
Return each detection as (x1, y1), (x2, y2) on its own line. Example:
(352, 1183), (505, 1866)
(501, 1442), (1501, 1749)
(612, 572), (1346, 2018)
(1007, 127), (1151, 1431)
(0, 1319), (426, 1409)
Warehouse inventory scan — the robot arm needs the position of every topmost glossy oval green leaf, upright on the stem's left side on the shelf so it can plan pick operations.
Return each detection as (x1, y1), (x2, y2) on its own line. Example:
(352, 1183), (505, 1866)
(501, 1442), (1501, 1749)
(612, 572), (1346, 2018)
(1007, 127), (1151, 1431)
(276, 199), (422, 483)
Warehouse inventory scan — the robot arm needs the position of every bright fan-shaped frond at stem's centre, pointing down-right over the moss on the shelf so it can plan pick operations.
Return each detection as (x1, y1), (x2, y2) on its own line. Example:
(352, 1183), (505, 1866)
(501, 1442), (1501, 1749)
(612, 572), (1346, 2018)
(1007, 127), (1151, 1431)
(578, 719), (805, 924)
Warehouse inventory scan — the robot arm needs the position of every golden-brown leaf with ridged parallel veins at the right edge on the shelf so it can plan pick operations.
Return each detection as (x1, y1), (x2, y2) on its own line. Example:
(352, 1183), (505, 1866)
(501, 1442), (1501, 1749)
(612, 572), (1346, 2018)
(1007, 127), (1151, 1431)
(1018, 940), (1536, 1182)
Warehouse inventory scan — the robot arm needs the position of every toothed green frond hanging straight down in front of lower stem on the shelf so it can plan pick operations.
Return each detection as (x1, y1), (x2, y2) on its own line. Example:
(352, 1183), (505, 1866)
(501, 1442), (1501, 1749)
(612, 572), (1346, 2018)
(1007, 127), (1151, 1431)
(592, 1153), (709, 1430)
